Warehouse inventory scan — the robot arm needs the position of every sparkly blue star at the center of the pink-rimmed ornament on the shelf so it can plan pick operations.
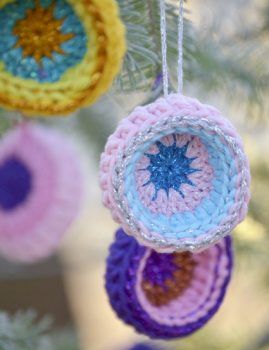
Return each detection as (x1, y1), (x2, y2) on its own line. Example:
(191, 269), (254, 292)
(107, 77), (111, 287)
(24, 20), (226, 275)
(141, 135), (201, 200)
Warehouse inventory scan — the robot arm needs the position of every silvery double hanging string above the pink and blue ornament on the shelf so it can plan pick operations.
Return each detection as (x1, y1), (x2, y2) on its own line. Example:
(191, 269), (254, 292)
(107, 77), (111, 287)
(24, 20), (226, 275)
(160, 0), (184, 97)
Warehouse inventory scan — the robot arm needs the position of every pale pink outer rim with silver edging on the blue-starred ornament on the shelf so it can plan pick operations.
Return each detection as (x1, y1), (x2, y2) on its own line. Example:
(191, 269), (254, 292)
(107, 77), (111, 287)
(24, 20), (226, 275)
(100, 94), (250, 252)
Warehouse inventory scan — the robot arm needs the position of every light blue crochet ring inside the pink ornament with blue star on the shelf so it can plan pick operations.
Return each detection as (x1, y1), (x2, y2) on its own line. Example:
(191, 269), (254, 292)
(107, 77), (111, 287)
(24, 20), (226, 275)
(124, 127), (236, 239)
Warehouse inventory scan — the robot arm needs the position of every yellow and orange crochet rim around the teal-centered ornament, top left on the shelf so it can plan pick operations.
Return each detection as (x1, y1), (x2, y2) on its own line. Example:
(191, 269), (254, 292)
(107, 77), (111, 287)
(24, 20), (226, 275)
(0, 0), (126, 116)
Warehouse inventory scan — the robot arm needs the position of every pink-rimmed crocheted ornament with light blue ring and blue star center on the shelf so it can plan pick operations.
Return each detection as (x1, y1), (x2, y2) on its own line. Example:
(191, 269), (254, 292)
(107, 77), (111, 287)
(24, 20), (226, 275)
(100, 94), (250, 252)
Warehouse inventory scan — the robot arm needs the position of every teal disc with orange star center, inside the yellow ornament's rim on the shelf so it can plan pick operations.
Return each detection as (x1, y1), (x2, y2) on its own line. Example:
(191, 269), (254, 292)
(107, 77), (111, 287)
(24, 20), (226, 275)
(0, 0), (87, 83)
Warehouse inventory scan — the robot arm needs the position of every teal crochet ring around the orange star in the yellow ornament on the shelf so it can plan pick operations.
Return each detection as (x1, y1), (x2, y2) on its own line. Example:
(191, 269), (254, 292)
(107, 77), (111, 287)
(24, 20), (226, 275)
(0, 0), (87, 83)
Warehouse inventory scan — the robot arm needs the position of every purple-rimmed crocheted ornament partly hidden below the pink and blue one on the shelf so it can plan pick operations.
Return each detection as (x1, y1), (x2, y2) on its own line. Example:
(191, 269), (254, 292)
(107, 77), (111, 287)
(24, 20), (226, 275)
(106, 229), (233, 339)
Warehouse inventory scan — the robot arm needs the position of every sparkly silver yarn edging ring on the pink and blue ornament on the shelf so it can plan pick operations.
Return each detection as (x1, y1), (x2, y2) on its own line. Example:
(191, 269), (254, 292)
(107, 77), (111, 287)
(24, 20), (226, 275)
(112, 116), (248, 252)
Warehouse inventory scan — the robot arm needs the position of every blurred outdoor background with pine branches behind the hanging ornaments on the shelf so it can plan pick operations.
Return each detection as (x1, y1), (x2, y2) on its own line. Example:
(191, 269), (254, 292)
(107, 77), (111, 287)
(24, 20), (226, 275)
(0, 0), (269, 350)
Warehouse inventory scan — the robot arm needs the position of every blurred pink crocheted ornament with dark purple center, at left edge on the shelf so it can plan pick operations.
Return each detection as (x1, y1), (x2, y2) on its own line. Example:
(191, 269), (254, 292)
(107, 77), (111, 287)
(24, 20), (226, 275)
(0, 124), (85, 262)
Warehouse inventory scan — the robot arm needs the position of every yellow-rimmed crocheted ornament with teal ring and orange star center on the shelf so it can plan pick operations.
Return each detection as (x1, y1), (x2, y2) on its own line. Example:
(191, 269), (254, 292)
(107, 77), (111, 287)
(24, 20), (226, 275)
(0, 0), (125, 116)
